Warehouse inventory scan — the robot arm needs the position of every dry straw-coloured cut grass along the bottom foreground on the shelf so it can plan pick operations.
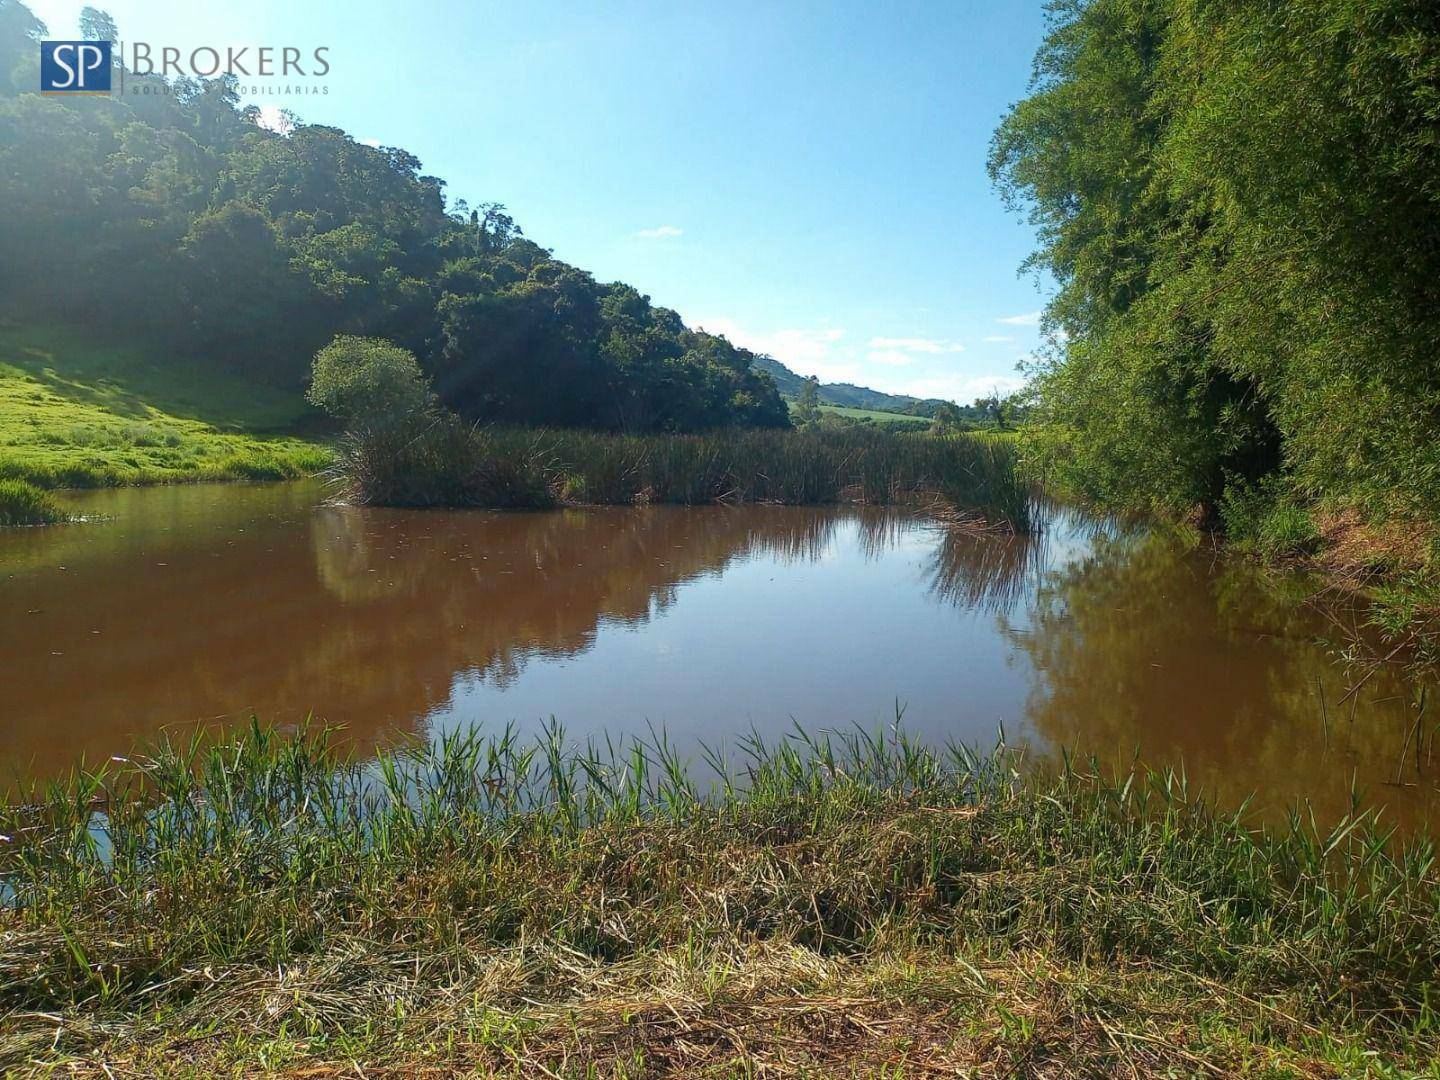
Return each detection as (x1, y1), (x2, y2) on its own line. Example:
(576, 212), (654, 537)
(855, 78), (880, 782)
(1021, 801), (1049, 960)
(2, 943), (1344, 1077)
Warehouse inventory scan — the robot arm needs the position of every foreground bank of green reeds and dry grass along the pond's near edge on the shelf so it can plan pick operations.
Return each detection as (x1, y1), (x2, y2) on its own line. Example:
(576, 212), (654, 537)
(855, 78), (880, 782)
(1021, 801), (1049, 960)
(0, 729), (1440, 1076)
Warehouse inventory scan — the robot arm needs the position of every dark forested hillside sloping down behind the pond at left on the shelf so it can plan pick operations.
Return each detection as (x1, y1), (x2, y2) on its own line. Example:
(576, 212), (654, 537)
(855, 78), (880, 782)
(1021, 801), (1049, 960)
(0, 0), (789, 432)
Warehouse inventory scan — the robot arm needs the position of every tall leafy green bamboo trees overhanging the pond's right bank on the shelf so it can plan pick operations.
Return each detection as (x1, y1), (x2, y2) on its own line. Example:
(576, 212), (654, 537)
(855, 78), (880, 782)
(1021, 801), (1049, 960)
(991, 0), (1440, 539)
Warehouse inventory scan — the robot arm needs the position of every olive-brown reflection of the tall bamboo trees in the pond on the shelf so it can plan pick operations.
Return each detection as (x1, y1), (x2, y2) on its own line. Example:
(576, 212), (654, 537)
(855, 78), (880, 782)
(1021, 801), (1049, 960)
(1017, 536), (1437, 822)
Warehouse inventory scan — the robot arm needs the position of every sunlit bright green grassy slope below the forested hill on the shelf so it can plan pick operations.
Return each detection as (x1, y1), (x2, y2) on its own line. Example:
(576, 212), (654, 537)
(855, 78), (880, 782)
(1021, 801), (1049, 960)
(0, 327), (331, 488)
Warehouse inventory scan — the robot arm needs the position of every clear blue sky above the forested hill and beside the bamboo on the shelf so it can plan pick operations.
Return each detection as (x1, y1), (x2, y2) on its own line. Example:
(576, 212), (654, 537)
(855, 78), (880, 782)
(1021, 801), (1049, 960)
(29, 0), (1044, 400)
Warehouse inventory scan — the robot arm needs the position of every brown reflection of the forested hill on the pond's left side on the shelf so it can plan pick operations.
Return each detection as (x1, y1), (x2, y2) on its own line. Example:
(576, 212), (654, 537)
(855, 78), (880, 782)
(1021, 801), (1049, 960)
(0, 504), (841, 773)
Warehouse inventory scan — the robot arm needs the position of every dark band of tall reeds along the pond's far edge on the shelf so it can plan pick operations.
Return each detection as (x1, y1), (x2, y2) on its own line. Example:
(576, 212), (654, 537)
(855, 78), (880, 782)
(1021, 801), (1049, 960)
(336, 418), (1032, 531)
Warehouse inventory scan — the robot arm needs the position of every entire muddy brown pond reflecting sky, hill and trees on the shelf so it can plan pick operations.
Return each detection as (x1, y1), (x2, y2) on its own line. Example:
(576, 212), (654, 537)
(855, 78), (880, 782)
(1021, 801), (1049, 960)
(0, 482), (1440, 828)
